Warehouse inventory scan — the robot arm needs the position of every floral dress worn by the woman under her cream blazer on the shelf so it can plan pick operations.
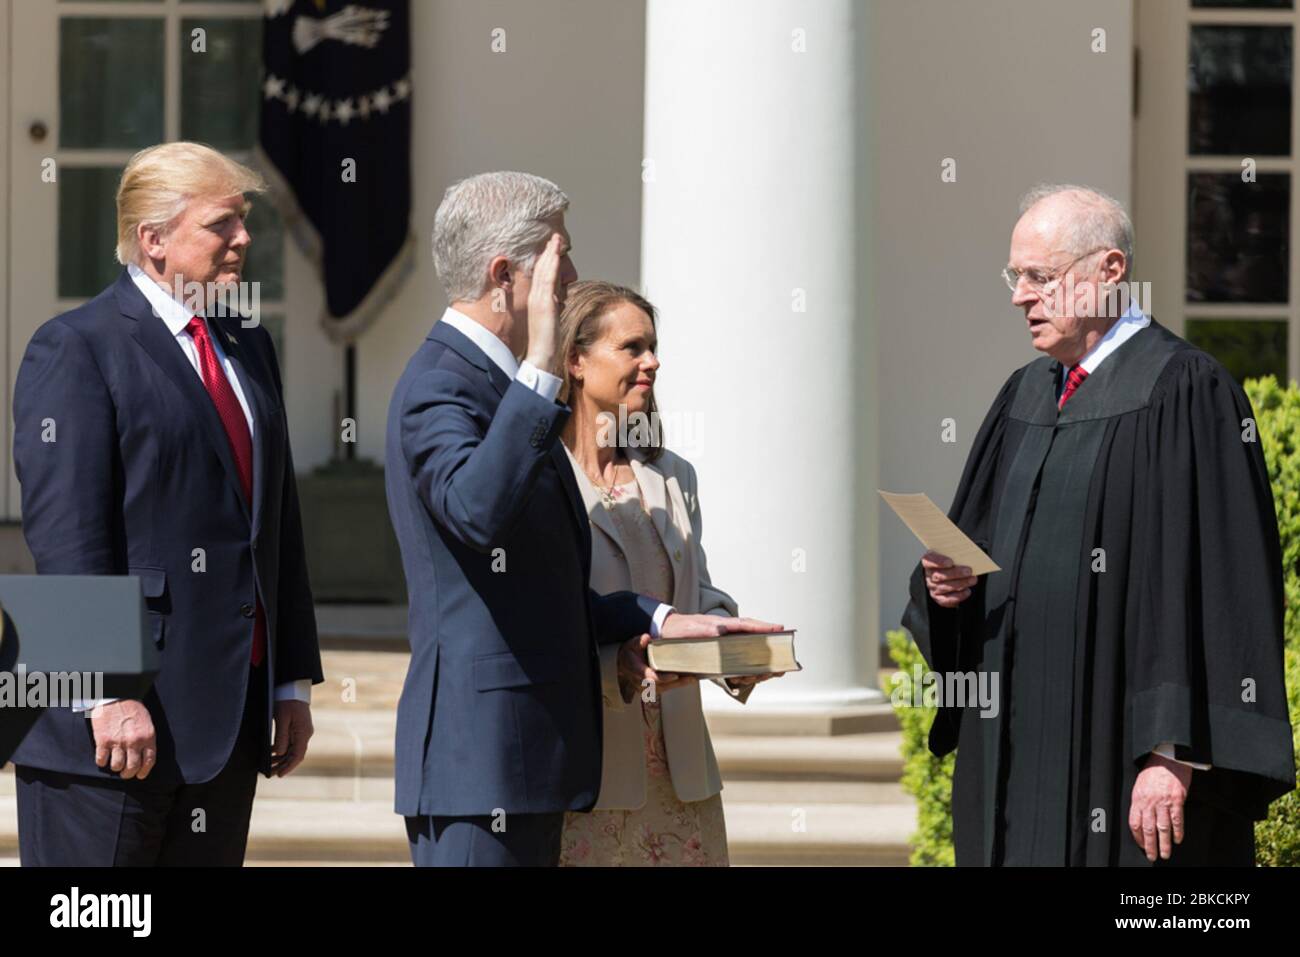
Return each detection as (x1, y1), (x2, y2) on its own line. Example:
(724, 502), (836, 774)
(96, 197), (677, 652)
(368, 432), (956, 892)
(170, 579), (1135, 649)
(560, 479), (728, 867)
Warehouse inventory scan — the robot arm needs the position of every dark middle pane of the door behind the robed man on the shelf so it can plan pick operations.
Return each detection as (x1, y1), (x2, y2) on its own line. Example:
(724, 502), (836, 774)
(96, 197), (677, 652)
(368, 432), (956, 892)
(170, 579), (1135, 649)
(1187, 173), (1291, 303)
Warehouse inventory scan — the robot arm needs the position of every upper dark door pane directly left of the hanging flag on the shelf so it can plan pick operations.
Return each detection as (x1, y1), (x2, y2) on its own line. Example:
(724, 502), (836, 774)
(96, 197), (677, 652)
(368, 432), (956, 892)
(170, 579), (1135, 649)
(181, 18), (261, 150)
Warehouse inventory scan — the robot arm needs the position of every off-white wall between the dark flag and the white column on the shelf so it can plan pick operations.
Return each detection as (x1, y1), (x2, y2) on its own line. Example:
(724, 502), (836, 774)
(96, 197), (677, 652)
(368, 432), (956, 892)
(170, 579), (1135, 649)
(340, 0), (645, 468)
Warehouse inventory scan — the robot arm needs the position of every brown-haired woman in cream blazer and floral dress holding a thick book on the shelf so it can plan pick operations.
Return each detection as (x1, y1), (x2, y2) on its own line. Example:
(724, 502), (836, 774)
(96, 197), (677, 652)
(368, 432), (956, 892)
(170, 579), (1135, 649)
(556, 282), (764, 866)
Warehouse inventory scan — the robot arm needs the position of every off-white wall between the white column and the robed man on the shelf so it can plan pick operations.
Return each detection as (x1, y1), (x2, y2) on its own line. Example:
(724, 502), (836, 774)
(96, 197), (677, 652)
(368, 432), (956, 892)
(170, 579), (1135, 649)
(862, 0), (1132, 647)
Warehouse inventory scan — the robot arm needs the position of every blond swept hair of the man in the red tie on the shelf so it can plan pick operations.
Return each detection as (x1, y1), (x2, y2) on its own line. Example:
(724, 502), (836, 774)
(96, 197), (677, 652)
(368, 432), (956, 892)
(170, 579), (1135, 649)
(117, 142), (267, 265)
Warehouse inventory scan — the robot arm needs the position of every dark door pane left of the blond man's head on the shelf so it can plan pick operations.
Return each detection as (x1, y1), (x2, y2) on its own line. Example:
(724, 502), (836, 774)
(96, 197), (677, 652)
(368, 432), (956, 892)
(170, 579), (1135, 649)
(59, 166), (122, 299)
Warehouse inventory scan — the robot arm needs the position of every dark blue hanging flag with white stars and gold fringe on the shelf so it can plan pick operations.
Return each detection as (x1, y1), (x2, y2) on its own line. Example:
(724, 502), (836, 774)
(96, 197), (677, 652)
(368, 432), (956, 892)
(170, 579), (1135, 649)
(259, 0), (415, 343)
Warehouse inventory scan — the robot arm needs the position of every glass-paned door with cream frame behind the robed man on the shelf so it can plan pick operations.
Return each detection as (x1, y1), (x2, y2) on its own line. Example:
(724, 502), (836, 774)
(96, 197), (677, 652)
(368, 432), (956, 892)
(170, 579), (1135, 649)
(1134, 0), (1300, 382)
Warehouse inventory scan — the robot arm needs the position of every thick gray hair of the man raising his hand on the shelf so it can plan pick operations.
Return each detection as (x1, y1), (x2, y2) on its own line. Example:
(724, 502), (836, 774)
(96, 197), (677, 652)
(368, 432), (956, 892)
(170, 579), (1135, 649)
(433, 173), (568, 303)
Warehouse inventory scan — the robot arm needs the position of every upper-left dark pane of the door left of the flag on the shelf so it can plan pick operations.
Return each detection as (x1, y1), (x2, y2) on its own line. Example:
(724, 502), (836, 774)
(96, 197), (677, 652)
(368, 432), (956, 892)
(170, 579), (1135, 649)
(59, 17), (163, 150)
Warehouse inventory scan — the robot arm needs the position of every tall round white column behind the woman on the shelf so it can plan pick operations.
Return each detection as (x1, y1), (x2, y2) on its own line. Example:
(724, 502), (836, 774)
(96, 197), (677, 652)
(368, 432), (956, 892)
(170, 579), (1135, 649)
(642, 0), (881, 710)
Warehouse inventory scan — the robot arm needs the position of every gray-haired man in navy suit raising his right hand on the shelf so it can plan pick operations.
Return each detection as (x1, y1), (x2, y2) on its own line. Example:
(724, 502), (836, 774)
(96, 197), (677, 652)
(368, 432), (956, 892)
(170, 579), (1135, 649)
(386, 173), (780, 866)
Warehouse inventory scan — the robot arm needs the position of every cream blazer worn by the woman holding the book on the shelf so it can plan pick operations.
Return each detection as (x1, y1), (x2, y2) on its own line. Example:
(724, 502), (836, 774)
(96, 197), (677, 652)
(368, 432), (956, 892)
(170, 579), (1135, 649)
(569, 449), (754, 810)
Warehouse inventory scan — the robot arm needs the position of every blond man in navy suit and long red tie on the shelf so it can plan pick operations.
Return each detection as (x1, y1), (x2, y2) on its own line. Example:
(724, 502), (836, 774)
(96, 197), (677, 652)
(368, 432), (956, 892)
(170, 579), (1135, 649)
(13, 143), (322, 866)
